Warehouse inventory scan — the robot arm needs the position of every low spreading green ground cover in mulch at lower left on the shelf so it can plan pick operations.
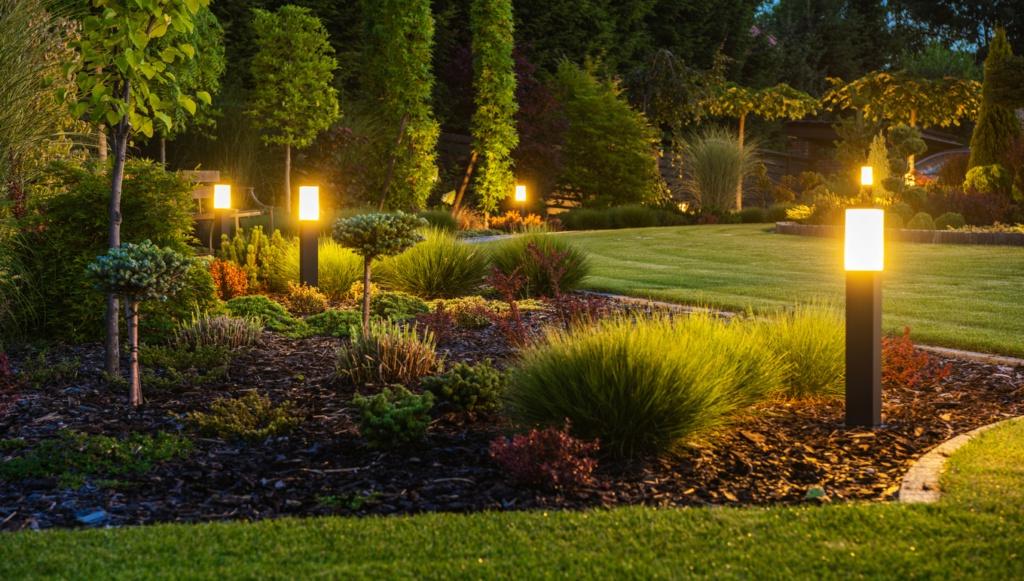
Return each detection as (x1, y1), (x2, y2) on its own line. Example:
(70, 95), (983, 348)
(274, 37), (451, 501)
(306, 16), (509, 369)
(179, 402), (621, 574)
(0, 430), (193, 488)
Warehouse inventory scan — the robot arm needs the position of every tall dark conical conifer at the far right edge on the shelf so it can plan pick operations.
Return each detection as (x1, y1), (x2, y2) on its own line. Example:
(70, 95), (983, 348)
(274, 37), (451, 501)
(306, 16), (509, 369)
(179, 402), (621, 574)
(968, 29), (1021, 168)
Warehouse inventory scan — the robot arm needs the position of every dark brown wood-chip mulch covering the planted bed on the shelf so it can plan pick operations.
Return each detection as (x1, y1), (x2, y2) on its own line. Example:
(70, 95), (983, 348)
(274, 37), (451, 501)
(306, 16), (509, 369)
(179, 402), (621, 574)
(0, 305), (1024, 531)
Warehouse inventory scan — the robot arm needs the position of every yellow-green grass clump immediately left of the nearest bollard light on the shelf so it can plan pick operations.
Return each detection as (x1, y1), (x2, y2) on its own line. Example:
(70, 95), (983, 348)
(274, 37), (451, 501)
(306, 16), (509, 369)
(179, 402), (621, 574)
(761, 305), (846, 398)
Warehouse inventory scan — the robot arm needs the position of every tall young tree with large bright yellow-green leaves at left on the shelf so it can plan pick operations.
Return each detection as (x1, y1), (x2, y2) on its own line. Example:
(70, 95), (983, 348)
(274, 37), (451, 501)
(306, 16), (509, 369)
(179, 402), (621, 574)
(61, 0), (211, 374)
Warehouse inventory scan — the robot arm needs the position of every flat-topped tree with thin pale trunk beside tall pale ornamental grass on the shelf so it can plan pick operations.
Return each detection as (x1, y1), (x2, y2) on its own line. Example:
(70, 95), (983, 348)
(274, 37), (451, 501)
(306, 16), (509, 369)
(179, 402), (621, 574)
(707, 83), (818, 210)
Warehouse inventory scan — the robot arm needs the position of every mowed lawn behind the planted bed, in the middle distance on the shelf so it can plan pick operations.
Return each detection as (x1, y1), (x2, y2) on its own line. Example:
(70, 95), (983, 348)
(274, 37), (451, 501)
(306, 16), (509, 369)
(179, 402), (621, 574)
(558, 224), (1024, 356)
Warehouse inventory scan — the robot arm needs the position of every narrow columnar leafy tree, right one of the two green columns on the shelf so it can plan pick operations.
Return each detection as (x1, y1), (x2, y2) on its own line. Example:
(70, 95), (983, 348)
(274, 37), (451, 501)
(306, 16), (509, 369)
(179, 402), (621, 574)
(454, 0), (519, 212)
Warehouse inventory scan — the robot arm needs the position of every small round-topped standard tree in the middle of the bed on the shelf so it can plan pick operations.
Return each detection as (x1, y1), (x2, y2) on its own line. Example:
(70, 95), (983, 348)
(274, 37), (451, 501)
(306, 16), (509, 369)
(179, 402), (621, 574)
(333, 212), (427, 332)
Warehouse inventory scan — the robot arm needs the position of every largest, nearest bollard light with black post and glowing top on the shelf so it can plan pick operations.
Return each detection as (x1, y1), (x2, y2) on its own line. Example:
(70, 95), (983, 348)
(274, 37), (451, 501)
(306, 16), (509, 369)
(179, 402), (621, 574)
(843, 208), (885, 426)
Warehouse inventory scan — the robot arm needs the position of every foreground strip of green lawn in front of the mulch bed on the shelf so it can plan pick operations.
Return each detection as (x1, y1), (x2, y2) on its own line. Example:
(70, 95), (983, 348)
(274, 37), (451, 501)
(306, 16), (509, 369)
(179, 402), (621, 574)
(0, 422), (1024, 579)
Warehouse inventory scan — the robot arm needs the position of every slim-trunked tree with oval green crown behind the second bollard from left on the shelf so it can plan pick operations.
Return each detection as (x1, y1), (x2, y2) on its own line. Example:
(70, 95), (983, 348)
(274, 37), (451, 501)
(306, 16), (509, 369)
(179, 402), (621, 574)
(249, 4), (341, 214)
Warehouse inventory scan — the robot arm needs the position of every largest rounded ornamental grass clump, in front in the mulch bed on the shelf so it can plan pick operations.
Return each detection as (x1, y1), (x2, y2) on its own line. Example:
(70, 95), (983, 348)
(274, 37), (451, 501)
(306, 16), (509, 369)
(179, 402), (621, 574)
(507, 315), (785, 456)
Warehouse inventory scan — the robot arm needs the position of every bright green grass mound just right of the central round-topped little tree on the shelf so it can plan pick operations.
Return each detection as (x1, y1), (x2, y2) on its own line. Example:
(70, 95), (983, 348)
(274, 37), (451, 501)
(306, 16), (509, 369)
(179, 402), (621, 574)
(376, 230), (487, 298)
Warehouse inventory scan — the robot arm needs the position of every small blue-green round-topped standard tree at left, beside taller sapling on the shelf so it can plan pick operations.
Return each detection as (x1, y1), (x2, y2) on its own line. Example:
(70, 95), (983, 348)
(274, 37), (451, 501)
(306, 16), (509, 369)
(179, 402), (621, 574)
(86, 240), (193, 407)
